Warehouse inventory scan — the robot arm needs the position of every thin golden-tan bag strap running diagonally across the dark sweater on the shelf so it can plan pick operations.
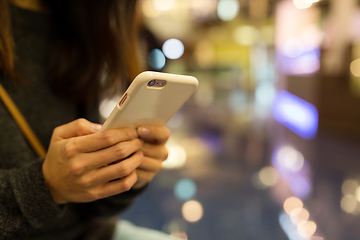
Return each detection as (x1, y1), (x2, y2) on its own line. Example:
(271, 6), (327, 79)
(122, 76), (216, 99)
(0, 84), (46, 158)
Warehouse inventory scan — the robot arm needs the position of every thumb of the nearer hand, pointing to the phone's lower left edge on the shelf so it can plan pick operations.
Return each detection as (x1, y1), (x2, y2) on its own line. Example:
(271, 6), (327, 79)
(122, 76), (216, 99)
(53, 118), (101, 140)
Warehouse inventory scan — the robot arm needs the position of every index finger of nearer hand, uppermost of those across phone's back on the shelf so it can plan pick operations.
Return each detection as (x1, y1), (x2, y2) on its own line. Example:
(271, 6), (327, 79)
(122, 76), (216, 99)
(69, 128), (137, 153)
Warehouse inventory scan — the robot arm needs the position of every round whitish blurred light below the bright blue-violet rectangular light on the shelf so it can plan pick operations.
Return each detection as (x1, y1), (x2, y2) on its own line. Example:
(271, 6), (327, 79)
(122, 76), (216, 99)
(277, 146), (304, 172)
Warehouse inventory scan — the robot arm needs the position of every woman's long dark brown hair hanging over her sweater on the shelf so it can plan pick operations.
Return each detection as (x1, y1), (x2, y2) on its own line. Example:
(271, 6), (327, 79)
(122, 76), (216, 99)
(0, 0), (141, 101)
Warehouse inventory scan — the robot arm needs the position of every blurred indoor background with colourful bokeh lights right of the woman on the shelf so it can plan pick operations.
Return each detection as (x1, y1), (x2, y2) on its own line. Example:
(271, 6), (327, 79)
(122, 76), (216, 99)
(107, 0), (360, 240)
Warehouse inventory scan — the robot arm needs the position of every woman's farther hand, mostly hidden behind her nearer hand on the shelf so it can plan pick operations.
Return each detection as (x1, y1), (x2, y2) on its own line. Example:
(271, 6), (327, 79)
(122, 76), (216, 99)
(133, 126), (170, 189)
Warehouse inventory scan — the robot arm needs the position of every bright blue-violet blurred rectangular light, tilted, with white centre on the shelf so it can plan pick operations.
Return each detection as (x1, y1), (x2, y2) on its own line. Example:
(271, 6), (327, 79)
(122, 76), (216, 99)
(273, 90), (319, 139)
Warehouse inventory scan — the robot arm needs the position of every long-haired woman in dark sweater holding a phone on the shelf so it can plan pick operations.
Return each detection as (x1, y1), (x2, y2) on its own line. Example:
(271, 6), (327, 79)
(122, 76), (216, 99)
(0, 0), (169, 240)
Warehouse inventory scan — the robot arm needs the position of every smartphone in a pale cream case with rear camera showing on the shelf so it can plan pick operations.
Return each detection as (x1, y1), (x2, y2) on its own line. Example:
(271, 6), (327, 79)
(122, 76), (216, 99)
(100, 71), (199, 131)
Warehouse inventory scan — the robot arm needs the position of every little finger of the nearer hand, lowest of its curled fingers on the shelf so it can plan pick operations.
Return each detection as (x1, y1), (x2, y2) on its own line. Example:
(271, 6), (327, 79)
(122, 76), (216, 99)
(100, 171), (137, 198)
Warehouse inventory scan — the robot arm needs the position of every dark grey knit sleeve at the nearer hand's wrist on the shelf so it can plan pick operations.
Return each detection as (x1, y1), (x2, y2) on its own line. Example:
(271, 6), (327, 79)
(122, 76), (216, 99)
(0, 159), (65, 239)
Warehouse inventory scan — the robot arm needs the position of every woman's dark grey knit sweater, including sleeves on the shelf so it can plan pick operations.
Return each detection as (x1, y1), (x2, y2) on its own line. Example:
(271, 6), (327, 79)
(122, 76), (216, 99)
(0, 5), (141, 240)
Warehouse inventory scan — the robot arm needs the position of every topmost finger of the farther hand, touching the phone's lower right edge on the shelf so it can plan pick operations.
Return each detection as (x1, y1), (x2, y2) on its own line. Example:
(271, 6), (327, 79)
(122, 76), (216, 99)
(137, 126), (170, 143)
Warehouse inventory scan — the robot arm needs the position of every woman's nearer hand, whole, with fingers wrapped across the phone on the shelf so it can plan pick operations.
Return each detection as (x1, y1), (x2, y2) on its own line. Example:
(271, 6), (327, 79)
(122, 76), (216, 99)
(42, 119), (143, 204)
